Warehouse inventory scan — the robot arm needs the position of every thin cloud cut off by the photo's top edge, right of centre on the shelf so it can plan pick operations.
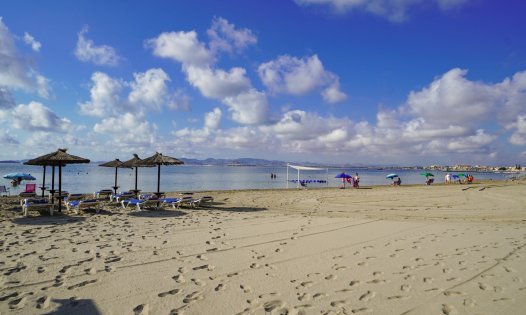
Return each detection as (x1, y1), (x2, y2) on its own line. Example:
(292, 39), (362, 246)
(295, 0), (470, 22)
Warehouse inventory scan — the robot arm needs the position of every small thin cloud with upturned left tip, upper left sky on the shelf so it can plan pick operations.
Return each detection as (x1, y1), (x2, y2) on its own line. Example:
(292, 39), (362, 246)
(75, 27), (120, 66)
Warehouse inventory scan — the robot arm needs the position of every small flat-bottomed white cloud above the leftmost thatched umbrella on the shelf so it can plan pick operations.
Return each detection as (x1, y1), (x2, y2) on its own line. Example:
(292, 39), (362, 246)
(8, 102), (72, 132)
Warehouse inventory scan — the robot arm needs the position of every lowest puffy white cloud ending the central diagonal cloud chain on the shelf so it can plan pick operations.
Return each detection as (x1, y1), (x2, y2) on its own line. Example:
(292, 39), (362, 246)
(223, 89), (269, 125)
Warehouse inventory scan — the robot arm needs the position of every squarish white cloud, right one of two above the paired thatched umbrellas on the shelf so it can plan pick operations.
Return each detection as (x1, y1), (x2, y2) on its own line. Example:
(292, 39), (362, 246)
(128, 68), (170, 110)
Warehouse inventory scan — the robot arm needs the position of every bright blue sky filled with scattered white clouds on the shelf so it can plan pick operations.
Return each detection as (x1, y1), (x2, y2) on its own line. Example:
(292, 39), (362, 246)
(0, 0), (526, 165)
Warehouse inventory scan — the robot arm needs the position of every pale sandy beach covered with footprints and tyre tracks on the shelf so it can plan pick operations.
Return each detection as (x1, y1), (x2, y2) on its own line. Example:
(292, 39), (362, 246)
(0, 181), (526, 314)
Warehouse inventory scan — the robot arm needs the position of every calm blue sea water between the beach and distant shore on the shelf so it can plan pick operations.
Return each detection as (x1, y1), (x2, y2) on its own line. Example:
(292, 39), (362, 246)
(0, 163), (507, 193)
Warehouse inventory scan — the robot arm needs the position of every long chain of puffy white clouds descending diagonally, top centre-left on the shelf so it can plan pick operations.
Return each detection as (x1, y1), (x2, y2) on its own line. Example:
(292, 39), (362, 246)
(146, 18), (269, 124)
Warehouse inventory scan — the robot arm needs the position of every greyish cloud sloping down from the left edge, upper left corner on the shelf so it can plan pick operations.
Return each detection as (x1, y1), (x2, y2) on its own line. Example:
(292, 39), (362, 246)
(0, 17), (49, 98)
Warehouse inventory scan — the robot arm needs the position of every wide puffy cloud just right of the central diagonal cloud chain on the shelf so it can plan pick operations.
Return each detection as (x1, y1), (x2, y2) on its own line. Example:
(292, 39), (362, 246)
(258, 55), (347, 103)
